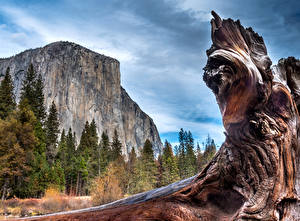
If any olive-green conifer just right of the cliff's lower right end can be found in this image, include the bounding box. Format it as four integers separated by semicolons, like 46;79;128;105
162;140;180;185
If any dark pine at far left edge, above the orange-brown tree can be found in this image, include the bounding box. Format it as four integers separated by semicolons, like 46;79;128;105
0;68;16;119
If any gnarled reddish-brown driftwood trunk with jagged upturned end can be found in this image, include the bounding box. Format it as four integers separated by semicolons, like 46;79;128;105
20;12;300;221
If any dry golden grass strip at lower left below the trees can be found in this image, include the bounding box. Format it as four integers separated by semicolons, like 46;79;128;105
0;188;92;220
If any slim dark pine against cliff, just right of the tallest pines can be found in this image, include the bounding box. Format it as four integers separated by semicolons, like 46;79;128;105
46;101;59;165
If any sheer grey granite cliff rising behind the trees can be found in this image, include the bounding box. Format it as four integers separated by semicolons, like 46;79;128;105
0;42;162;155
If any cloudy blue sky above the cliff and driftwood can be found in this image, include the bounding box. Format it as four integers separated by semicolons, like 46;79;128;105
0;0;300;148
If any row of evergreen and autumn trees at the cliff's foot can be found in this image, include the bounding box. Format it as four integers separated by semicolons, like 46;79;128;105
0;64;216;204
